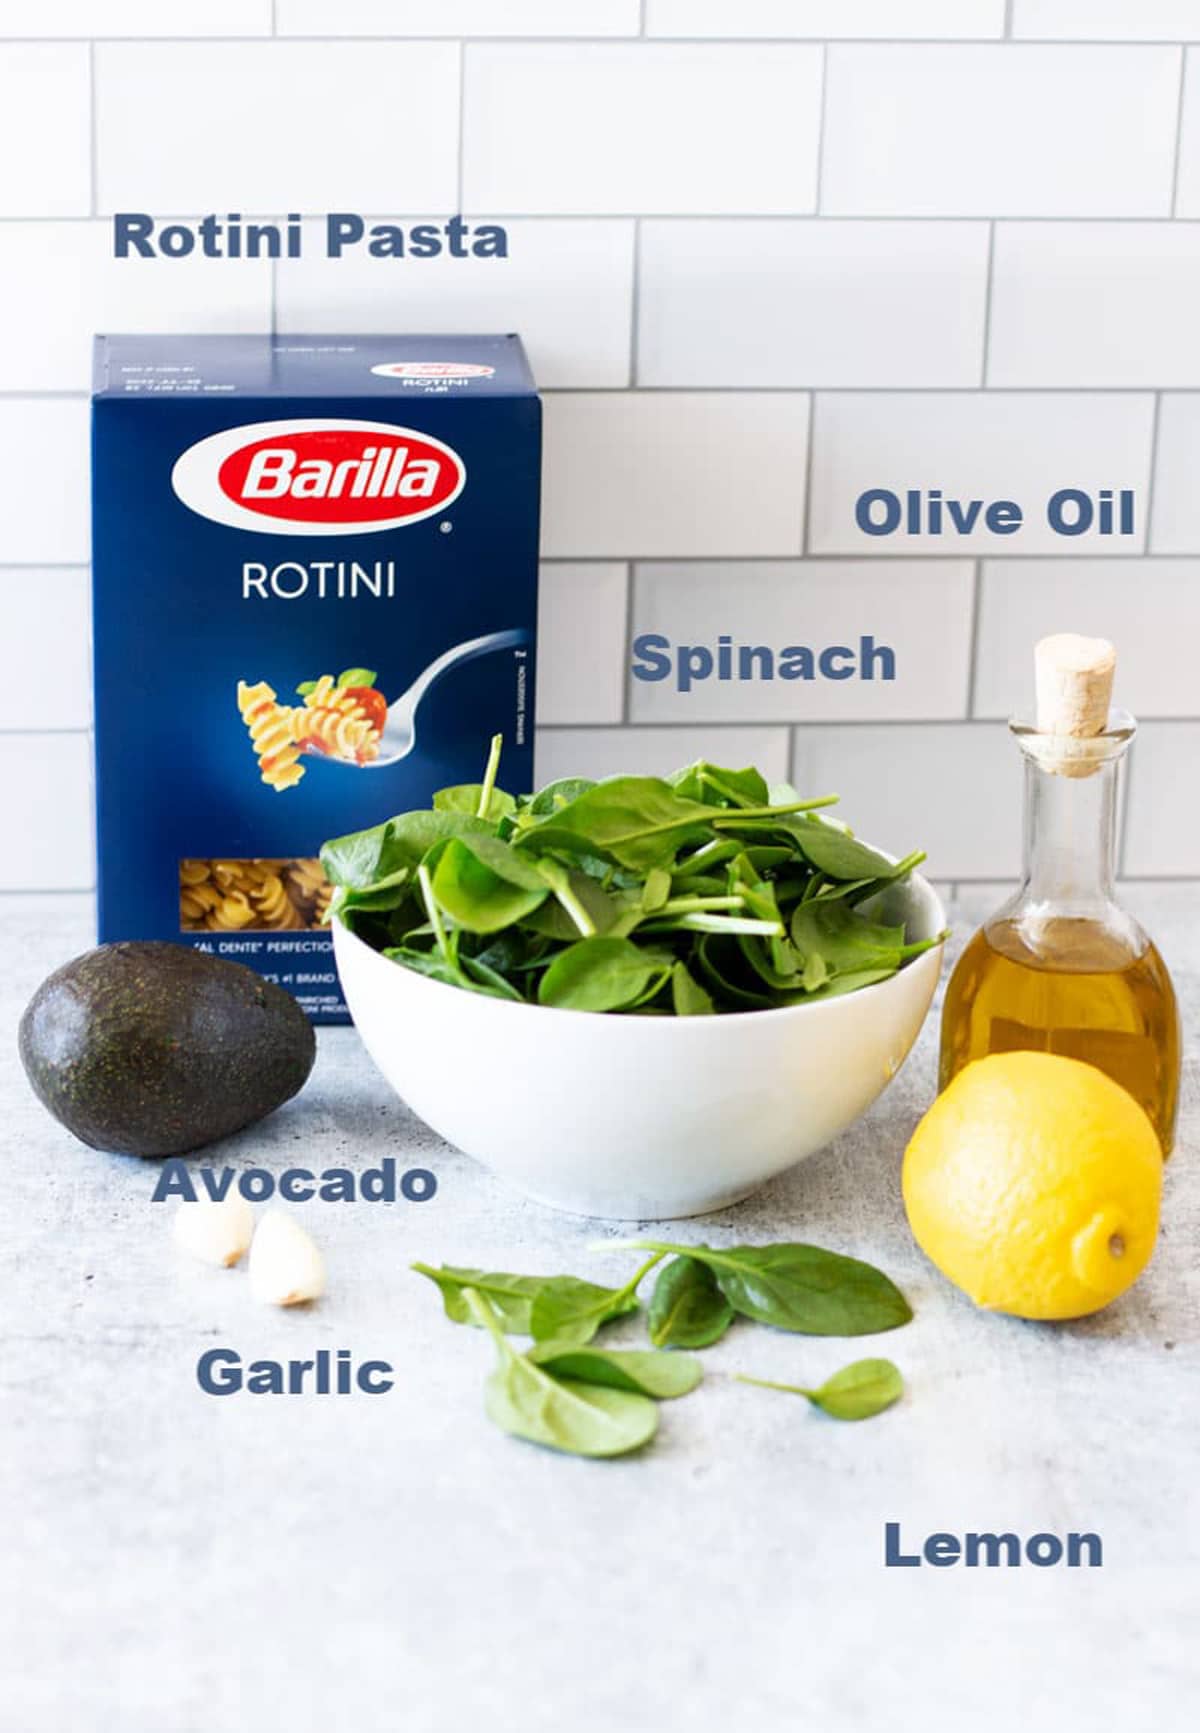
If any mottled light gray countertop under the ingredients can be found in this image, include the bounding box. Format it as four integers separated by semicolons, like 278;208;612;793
0;886;1200;1733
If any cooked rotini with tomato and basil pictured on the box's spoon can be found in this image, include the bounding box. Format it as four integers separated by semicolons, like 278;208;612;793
238;667;387;792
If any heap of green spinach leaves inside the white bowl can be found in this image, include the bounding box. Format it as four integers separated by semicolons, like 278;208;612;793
321;737;943;1017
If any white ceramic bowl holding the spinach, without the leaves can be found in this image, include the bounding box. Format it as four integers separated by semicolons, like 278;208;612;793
333;873;945;1220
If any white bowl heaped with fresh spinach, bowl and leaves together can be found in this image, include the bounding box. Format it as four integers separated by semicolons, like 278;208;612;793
321;740;945;1220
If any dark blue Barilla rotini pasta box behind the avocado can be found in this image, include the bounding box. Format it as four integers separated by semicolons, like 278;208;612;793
92;336;541;1022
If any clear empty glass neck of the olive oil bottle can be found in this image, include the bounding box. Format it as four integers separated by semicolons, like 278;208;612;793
1021;756;1118;918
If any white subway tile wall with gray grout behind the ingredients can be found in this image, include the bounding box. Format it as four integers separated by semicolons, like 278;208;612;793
0;0;1200;891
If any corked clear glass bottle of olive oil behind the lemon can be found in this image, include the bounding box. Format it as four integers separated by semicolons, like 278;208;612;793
940;634;1181;1154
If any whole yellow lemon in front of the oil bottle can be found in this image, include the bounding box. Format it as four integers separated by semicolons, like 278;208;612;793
903;1054;1162;1319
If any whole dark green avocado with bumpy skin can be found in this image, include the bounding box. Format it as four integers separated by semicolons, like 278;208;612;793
19;941;316;1156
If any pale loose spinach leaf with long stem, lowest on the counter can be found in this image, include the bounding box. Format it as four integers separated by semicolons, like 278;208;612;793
463;1288;659;1456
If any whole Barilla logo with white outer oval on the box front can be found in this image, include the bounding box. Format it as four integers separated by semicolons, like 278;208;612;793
172;419;466;535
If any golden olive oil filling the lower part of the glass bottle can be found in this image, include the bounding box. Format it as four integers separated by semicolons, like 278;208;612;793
940;912;1181;1154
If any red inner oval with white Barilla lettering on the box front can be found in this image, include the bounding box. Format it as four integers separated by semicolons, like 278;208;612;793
217;426;465;525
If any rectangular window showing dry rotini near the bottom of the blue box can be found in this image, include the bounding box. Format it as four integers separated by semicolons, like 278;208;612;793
179;860;333;932
